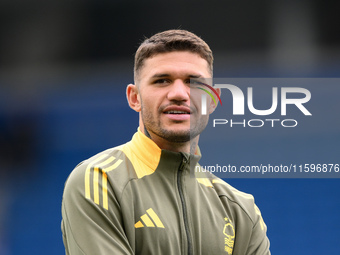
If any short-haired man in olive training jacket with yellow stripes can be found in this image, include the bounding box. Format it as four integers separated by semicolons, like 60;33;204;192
62;30;270;255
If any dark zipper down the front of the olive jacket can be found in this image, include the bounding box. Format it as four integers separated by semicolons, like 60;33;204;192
177;154;193;255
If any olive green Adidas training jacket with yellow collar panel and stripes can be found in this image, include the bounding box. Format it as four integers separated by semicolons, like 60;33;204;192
61;130;270;255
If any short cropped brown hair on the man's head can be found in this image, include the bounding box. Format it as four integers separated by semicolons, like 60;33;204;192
134;29;214;82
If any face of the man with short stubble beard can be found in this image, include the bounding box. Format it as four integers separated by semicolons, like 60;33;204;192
138;52;211;143
